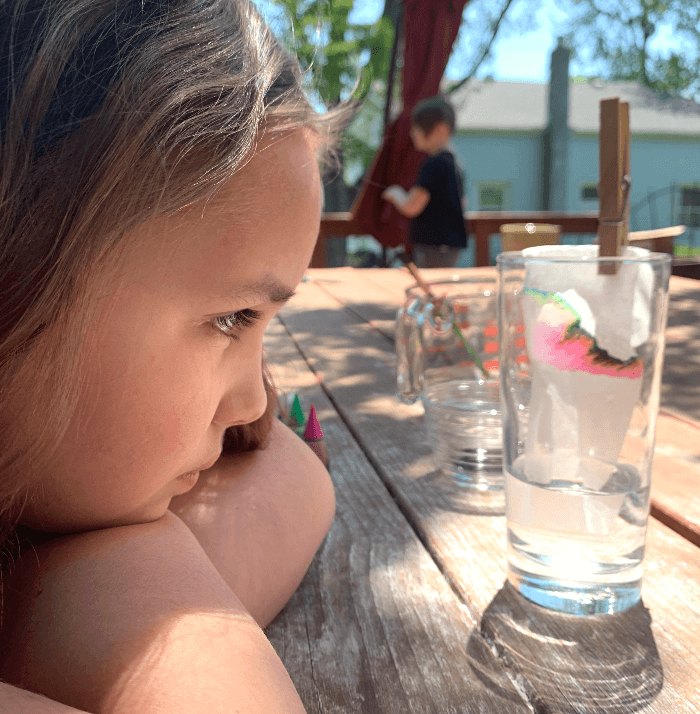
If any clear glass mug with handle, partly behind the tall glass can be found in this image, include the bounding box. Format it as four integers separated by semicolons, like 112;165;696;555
396;274;505;506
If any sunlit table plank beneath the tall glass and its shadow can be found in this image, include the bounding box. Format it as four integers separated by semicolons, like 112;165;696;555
281;275;700;712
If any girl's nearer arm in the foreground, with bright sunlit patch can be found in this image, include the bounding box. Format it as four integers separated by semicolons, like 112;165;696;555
0;512;303;714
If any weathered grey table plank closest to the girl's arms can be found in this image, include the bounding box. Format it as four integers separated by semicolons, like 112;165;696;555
265;323;530;714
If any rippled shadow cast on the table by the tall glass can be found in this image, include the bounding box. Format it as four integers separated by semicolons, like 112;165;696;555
467;582;664;714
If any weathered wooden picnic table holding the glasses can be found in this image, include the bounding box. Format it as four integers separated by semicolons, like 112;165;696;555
266;268;700;714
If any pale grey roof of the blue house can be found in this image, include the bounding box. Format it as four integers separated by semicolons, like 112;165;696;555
450;80;700;136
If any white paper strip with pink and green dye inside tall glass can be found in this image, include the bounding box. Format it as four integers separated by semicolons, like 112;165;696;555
523;246;654;533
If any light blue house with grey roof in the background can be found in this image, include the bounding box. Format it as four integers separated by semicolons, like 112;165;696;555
450;60;700;264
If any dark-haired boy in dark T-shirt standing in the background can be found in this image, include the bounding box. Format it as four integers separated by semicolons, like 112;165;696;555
382;97;467;268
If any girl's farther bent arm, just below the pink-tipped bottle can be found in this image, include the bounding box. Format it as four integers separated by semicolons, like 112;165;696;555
170;420;335;627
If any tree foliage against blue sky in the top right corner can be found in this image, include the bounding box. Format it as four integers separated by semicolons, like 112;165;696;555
560;0;700;102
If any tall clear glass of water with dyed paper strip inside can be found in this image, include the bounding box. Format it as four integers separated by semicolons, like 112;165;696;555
497;246;671;615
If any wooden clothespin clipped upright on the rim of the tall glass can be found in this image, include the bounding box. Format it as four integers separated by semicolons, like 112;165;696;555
598;97;632;275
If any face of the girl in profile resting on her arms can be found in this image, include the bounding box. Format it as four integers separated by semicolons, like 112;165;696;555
21;130;321;531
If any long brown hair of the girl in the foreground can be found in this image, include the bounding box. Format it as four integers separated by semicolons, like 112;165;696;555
0;0;337;541
